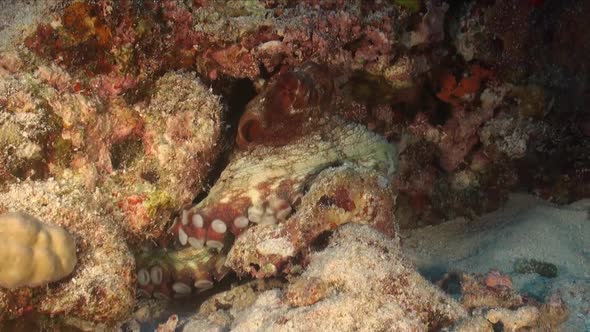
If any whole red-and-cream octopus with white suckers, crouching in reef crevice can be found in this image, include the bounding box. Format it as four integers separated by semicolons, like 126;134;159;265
137;64;397;299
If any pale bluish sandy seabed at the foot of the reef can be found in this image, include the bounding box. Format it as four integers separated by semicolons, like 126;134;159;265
402;194;590;331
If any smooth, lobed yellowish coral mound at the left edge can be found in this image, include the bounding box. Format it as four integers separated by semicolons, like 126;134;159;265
0;213;78;289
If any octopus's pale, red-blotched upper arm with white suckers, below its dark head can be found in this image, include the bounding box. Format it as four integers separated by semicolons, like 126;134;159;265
171;118;396;254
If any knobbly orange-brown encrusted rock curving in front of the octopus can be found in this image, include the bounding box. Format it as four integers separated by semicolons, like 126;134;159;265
226;163;398;278
